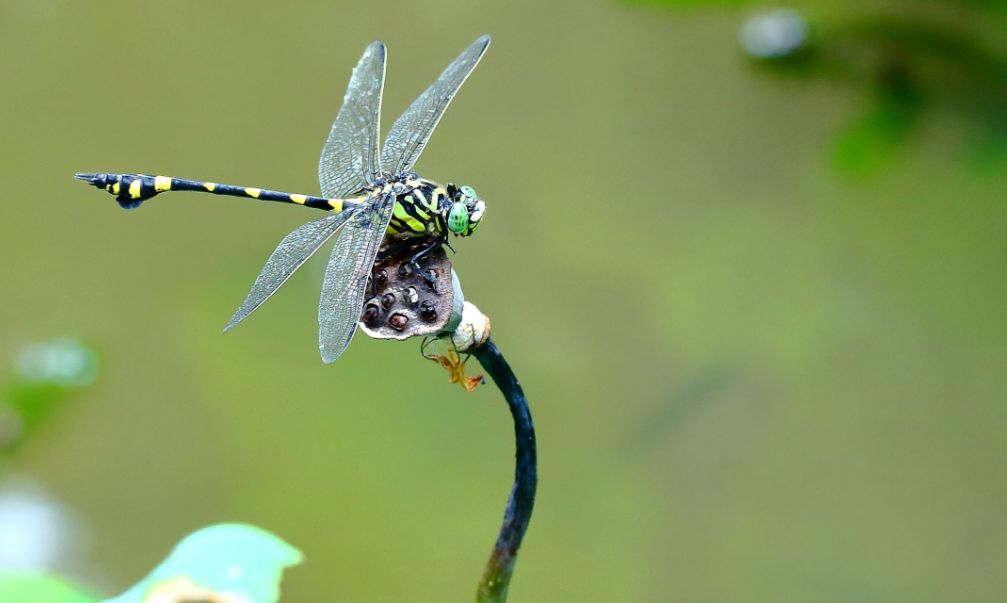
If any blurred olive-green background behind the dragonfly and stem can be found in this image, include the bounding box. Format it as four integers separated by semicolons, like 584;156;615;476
0;0;1007;603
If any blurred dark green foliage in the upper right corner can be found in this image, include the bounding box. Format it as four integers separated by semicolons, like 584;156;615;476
769;9;1007;175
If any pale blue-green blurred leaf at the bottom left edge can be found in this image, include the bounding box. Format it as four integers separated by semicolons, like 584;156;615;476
105;523;302;603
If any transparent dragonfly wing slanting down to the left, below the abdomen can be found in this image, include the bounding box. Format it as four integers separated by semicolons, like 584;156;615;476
224;208;358;332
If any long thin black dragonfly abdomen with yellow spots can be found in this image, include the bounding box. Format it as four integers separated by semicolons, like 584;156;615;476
77;174;359;211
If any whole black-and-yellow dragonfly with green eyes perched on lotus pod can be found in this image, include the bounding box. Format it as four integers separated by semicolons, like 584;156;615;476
76;35;489;363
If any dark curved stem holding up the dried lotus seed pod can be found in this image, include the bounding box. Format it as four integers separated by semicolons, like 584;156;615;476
472;340;538;603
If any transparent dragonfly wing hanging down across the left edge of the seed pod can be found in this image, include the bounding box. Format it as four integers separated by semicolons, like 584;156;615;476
318;194;395;363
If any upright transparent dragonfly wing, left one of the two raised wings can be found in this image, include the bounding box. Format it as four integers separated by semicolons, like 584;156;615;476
318;42;385;198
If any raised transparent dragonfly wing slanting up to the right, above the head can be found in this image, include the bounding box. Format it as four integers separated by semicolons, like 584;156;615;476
381;35;489;175
